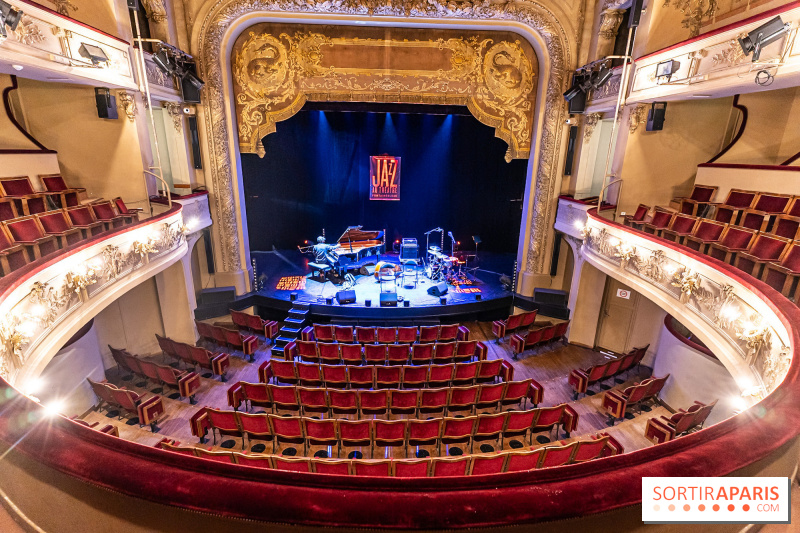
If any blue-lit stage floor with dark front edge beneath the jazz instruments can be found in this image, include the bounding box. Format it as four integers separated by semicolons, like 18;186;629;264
247;250;514;325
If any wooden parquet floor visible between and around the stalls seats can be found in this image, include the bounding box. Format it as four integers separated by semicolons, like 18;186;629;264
81;319;670;458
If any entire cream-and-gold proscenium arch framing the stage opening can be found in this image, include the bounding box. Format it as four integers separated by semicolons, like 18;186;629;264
192;0;574;286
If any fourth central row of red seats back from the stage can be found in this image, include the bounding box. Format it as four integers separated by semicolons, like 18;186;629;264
228;379;544;418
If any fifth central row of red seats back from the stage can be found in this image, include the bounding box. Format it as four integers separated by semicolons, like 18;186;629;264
190;404;578;457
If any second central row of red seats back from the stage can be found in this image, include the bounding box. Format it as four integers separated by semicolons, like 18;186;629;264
283;340;489;365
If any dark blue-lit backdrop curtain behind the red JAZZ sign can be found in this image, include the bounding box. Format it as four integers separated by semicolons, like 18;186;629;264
242;110;528;252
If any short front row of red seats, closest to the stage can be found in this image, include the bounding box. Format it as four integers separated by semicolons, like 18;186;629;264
300;324;469;344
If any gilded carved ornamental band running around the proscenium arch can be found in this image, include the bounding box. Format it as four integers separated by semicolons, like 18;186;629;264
196;0;573;272
